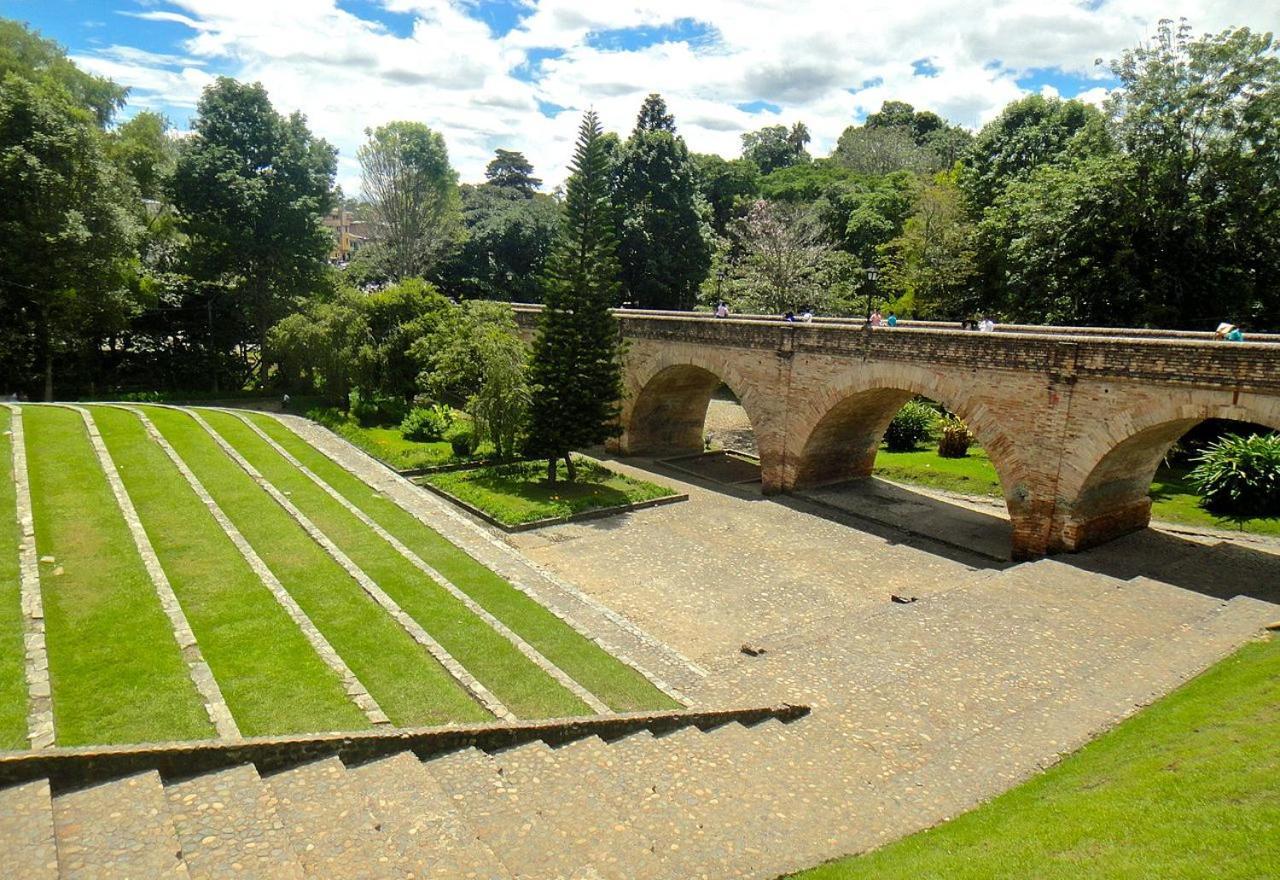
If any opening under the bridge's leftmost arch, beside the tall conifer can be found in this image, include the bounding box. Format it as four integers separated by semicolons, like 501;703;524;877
622;363;756;455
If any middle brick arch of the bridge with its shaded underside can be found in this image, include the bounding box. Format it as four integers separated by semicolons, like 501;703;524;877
787;365;1029;516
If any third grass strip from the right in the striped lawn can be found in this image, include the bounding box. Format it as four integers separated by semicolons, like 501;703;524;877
142;407;492;727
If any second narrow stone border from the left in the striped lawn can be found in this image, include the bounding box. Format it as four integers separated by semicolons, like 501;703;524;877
67;405;241;739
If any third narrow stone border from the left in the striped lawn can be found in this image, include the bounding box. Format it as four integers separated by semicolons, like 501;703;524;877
120;405;392;727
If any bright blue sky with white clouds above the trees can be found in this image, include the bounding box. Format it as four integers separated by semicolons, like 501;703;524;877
0;0;1280;193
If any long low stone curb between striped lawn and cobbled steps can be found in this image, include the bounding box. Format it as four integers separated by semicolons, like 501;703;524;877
0;703;809;789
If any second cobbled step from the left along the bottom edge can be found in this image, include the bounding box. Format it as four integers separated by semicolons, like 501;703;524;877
54;770;189;880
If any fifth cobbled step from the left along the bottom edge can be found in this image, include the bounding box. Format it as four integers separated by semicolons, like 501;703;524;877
348;752;511;880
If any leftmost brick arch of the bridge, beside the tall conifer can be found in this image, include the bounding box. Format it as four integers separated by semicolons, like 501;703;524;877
618;347;768;460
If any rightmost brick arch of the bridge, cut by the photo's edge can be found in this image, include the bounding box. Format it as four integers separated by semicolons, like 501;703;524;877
1051;391;1280;550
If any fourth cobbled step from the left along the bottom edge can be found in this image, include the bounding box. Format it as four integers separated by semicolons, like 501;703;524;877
264;757;408;880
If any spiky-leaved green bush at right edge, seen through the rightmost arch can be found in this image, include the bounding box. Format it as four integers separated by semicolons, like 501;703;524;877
1188;434;1280;519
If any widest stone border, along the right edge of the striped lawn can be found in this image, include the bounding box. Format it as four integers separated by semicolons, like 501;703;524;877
268;413;709;706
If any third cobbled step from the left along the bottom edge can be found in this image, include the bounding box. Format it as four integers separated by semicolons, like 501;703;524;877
165;764;303;880
